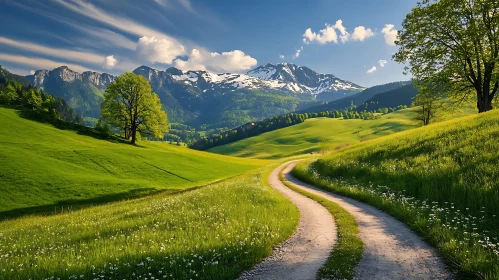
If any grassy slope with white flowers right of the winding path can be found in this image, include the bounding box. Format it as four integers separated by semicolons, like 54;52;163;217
293;111;499;279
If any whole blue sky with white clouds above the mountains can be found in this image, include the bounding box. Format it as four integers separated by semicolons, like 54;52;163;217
0;0;417;87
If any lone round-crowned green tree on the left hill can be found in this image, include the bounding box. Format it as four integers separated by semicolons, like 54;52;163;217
101;73;169;144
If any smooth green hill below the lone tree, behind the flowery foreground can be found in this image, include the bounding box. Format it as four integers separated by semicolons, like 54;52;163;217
0;107;269;219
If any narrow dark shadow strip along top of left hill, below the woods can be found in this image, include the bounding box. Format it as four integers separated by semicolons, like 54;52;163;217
10;106;131;147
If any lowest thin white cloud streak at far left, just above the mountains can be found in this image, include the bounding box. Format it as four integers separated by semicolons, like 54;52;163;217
0;53;96;72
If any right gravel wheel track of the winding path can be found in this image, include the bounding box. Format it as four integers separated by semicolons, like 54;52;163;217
283;162;453;279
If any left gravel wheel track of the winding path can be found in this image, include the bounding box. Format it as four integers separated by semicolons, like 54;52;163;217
239;163;337;280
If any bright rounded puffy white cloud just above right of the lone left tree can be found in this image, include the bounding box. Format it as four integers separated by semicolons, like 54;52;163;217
137;36;185;64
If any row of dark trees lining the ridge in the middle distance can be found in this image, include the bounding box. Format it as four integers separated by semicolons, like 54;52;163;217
189;106;407;150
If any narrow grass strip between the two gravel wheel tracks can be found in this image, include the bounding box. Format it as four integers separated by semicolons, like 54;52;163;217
279;168;364;279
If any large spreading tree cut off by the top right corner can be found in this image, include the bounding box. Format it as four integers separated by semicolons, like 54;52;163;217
394;0;499;112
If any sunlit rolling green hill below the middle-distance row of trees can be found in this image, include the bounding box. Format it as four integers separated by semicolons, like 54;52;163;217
209;109;419;159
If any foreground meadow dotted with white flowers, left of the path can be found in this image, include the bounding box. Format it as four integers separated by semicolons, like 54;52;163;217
0;167;299;280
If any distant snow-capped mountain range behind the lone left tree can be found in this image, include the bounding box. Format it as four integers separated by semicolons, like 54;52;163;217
26;63;364;127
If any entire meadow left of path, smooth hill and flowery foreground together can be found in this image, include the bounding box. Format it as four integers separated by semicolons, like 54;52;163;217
0;108;299;280
